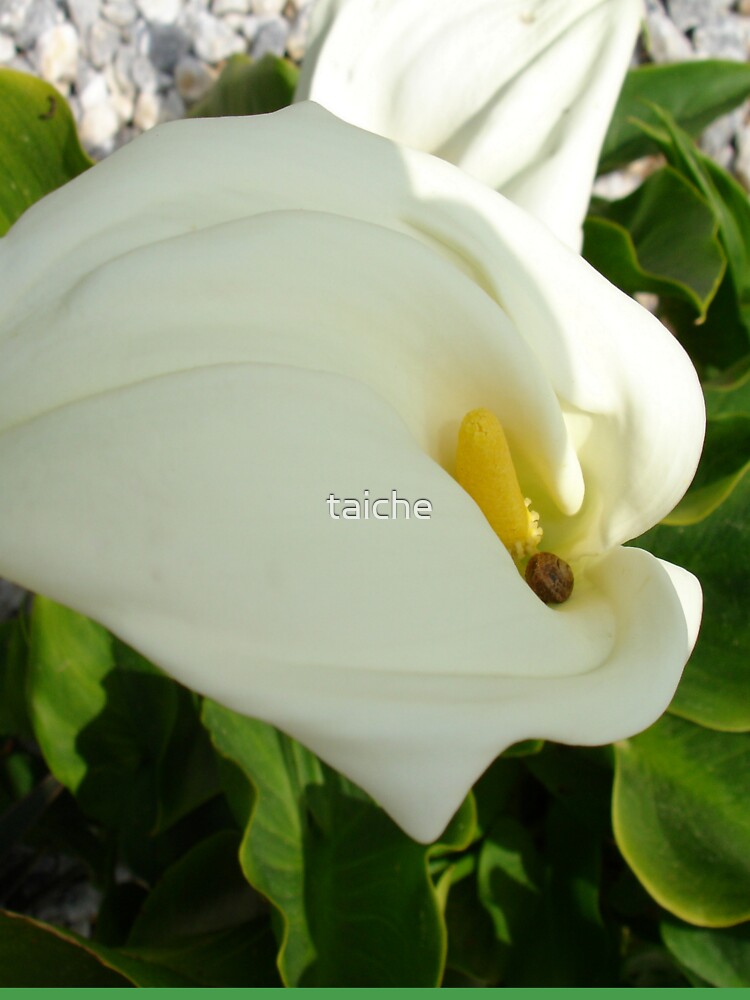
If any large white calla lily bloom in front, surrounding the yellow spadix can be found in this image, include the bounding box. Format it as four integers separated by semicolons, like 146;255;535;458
0;104;704;841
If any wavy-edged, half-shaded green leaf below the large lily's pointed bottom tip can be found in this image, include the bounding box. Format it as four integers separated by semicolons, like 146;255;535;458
204;702;474;987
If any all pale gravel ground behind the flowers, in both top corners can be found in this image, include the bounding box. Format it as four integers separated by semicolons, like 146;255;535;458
0;0;750;176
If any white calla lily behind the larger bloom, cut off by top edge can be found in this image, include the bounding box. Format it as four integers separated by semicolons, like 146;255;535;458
297;0;643;249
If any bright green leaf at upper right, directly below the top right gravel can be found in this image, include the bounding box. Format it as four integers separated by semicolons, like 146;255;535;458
599;59;750;173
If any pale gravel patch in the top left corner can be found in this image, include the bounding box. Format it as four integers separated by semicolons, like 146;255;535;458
0;0;310;158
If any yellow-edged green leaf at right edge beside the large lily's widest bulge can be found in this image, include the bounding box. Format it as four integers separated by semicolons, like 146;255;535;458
664;413;750;525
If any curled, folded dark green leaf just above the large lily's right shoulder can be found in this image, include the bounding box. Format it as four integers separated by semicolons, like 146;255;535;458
583;167;726;318
